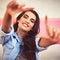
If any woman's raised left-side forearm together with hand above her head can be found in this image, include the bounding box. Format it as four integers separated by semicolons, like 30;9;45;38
2;0;33;33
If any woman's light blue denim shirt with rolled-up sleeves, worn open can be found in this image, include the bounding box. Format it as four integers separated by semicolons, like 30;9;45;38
0;27;46;60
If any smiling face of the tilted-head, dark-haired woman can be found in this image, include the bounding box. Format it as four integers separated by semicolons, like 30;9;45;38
18;11;36;32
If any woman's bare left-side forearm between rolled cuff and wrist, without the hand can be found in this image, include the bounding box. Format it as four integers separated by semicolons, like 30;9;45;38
2;12;11;33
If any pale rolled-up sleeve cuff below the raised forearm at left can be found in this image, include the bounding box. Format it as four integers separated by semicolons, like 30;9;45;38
0;26;14;43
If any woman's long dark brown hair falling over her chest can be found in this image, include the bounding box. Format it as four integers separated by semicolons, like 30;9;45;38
14;10;40;60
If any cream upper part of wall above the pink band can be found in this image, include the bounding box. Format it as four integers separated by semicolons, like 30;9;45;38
0;0;60;18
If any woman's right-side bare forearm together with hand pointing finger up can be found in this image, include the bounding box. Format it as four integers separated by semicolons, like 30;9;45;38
37;16;60;47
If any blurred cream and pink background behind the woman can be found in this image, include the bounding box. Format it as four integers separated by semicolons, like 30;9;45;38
0;0;60;60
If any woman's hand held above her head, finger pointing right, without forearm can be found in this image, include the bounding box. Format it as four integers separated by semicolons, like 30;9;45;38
7;0;33;16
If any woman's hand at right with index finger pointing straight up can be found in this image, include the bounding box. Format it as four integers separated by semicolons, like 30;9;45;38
45;16;60;43
